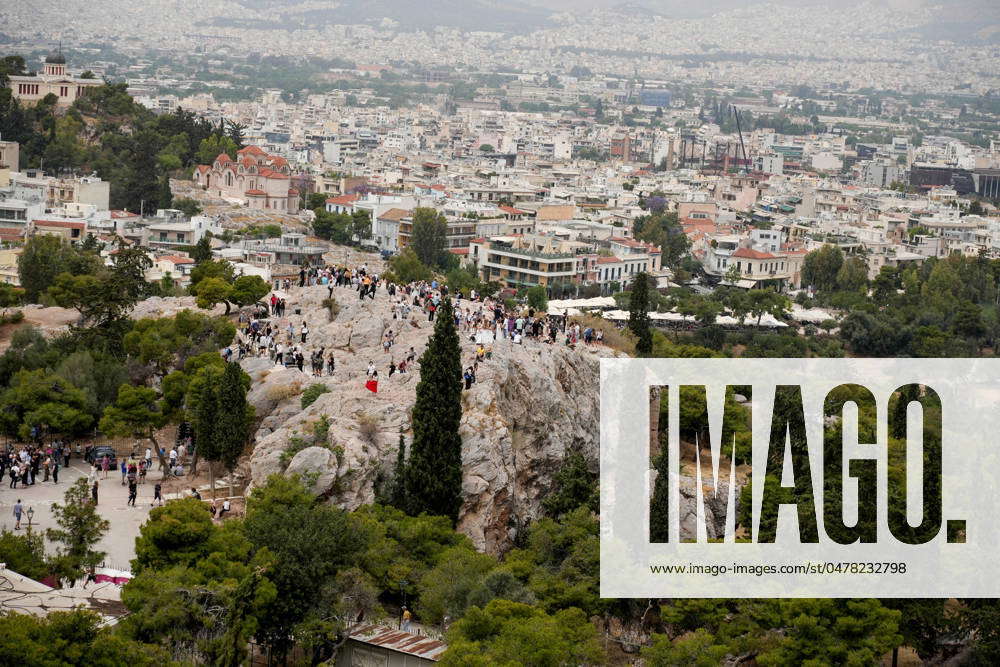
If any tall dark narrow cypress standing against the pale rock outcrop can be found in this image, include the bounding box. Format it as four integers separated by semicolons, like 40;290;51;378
404;299;462;523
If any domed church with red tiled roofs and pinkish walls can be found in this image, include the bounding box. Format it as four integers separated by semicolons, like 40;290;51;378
194;146;299;213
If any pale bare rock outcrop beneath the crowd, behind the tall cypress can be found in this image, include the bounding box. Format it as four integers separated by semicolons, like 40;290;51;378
243;286;614;552
